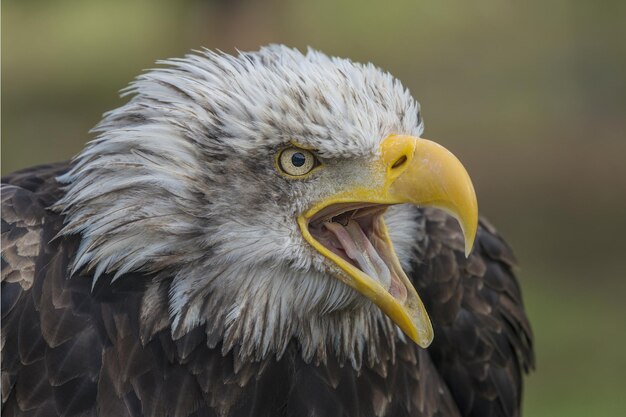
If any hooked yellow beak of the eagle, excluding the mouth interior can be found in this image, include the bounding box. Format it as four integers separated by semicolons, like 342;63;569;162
298;135;478;347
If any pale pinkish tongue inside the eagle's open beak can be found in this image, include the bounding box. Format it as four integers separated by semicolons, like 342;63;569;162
325;220;391;289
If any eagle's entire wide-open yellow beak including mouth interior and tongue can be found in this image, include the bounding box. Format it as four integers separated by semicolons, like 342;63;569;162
296;135;478;348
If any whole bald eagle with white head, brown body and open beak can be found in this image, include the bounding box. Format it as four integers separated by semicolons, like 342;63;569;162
2;45;533;417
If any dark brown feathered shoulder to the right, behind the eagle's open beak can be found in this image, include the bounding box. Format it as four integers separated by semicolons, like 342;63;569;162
412;209;534;417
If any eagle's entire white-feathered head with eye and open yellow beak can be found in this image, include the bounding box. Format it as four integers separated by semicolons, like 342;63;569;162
57;46;477;366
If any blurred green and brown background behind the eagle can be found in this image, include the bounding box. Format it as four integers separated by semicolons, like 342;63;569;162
2;0;626;417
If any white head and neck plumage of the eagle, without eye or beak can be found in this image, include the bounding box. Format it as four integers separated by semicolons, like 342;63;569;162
57;46;423;367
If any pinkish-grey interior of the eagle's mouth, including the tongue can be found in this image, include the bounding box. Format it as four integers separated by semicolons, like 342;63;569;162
308;203;407;304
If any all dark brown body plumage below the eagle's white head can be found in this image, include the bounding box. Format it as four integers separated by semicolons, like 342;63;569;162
2;165;533;417
